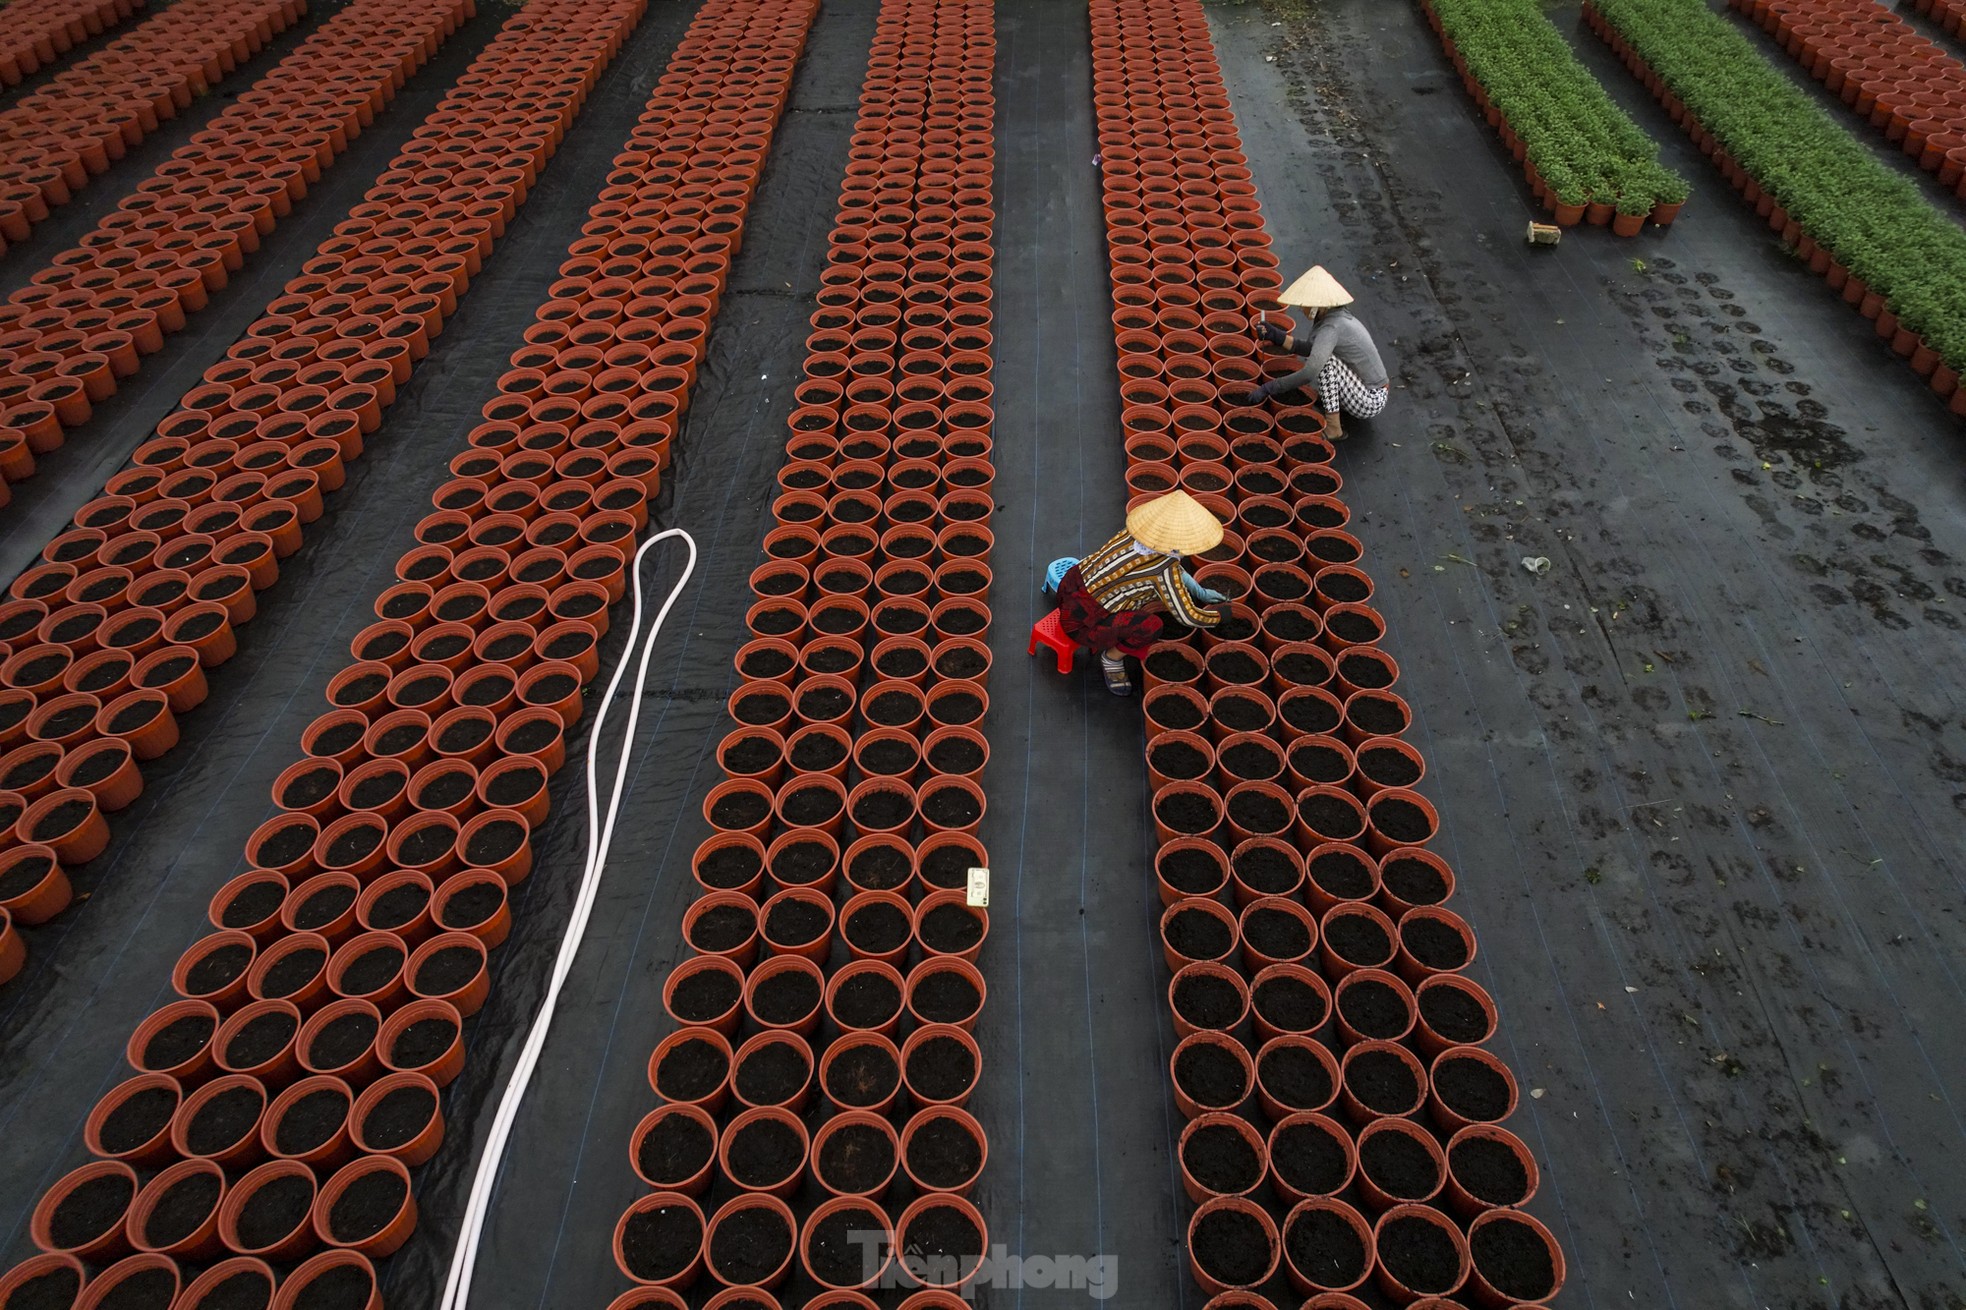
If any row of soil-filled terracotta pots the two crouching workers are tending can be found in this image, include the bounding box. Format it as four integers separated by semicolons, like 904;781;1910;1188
1093;0;1561;1304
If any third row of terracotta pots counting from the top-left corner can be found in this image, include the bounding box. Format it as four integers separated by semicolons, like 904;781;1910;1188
0;0;466;476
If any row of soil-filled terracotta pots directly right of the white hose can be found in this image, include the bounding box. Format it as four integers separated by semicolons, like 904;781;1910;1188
615;2;993;1310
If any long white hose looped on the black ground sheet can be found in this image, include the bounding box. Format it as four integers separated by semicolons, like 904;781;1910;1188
442;527;696;1310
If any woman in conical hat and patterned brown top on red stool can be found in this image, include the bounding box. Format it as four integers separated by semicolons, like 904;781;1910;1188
1046;492;1229;696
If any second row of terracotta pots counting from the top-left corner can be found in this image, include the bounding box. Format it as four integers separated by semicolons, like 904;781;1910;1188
0;0;307;247
